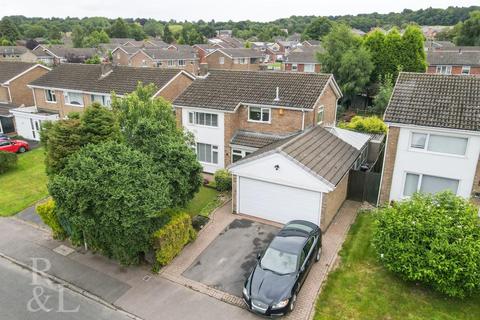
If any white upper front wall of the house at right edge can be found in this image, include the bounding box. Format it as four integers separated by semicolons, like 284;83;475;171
390;127;480;200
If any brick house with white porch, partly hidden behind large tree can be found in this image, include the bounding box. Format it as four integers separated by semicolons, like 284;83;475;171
10;64;195;140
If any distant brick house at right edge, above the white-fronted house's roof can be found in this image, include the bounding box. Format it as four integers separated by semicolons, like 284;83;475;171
427;47;480;76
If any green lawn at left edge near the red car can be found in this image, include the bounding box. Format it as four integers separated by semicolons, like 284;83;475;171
0;148;48;217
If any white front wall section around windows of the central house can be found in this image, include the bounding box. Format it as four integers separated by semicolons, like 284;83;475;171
182;108;225;173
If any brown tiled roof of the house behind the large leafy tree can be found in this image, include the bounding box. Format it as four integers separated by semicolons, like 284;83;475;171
30;63;186;95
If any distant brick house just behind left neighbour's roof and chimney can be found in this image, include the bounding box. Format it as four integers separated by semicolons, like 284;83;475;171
129;47;200;75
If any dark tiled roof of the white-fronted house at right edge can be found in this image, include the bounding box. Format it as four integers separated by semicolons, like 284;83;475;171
384;72;480;131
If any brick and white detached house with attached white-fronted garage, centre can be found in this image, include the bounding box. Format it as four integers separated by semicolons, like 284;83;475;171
173;70;369;229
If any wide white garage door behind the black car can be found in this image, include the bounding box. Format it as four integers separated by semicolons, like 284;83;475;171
237;177;321;225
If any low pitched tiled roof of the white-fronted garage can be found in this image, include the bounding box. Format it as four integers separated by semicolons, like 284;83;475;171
231;126;360;186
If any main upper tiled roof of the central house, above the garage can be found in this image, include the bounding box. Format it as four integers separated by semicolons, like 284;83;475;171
174;70;333;111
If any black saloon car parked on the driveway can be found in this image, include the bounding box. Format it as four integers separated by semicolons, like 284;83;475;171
243;220;322;316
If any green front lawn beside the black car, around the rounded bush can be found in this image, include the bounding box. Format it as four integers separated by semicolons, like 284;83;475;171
315;214;480;320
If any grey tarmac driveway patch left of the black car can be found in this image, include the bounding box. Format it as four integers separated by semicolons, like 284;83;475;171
182;219;279;297
